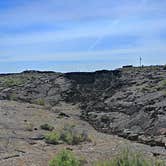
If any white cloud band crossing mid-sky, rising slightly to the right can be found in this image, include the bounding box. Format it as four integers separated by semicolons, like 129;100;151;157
0;19;166;46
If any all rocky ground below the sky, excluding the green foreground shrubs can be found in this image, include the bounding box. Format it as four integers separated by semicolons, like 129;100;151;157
0;66;166;166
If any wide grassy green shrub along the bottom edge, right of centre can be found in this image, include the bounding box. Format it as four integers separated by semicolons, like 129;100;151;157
94;150;165;166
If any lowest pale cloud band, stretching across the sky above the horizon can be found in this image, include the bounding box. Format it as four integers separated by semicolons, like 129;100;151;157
0;43;166;62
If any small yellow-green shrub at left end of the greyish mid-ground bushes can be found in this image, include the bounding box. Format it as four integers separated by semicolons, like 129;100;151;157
45;132;60;145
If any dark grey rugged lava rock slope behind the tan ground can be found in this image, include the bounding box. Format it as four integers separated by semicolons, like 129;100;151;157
0;66;166;146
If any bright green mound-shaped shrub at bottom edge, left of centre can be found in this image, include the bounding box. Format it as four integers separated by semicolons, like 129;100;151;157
49;150;81;166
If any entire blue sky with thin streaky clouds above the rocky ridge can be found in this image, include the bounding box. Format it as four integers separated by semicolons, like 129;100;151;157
0;0;166;73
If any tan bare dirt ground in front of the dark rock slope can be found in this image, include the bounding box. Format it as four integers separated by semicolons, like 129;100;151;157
0;101;166;166
